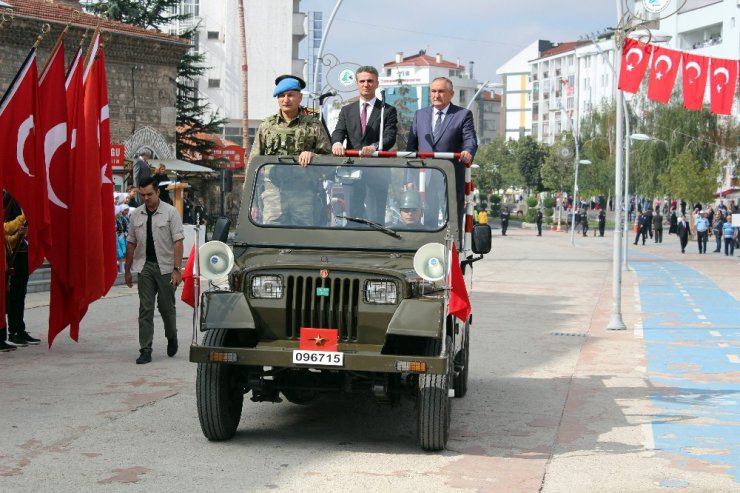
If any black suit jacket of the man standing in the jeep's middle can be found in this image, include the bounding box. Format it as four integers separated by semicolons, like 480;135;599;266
331;99;398;151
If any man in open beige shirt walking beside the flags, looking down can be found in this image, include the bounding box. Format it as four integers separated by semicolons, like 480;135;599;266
125;176;185;365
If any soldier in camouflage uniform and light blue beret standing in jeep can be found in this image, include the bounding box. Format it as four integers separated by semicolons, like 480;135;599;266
250;75;331;226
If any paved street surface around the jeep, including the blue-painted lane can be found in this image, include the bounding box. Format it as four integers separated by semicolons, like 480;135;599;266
0;228;740;492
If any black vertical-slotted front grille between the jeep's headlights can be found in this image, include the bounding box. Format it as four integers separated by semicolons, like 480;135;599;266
285;276;362;341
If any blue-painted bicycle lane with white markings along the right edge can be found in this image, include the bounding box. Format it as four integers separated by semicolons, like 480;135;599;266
630;253;740;483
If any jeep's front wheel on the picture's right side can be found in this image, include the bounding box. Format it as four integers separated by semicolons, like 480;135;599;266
417;375;450;450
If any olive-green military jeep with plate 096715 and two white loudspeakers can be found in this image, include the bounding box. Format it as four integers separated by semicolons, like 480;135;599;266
190;156;491;450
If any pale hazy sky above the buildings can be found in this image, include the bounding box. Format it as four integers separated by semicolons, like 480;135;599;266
300;0;617;81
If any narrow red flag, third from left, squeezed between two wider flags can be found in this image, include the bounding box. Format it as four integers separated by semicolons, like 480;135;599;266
49;48;84;348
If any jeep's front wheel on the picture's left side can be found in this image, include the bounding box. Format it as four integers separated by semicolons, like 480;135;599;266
195;329;244;441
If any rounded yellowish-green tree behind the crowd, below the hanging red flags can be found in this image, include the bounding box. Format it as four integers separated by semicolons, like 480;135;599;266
659;148;718;203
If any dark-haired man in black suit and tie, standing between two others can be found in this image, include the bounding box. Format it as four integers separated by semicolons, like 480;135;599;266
331;66;398;223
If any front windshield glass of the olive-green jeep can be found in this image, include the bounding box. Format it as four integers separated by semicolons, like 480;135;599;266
248;160;449;232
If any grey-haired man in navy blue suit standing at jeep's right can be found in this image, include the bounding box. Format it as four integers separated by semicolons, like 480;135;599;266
406;77;478;231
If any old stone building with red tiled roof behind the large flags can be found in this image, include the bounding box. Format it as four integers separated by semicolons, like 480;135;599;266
0;0;189;160
